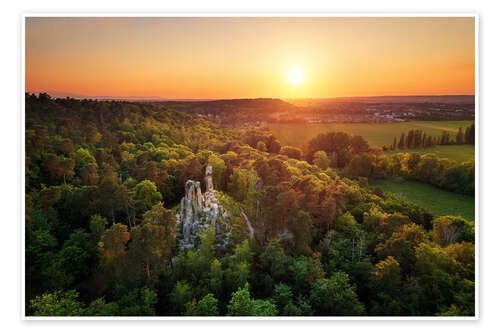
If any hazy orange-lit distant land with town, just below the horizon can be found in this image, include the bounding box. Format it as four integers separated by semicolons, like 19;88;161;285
148;95;475;125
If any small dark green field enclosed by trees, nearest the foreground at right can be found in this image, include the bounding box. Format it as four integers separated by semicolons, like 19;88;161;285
372;180;474;221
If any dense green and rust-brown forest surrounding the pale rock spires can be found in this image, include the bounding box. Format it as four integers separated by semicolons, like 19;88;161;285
25;93;475;316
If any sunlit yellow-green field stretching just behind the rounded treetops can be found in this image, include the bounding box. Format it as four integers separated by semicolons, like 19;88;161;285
268;120;474;147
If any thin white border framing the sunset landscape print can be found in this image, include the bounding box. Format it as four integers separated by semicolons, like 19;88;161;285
19;11;480;321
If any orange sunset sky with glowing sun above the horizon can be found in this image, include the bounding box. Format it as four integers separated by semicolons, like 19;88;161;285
25;17;475;99
